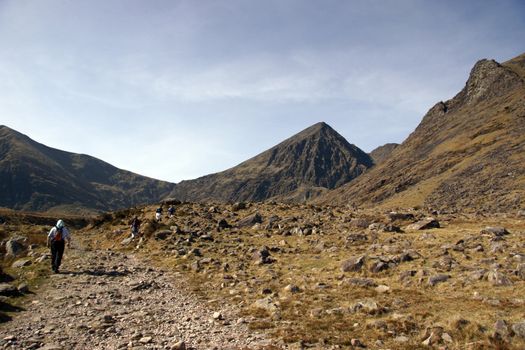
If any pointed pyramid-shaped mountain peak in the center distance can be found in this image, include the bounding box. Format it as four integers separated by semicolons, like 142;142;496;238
172;123;373;202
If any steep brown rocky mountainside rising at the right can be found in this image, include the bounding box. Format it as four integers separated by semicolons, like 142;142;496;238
319;55;525;211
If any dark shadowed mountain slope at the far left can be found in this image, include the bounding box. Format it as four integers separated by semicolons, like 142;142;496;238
0;126;175;211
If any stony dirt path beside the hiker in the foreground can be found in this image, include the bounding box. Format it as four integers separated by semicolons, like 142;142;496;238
0;241;264;350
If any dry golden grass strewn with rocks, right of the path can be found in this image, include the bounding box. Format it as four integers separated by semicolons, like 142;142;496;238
81;204;525;349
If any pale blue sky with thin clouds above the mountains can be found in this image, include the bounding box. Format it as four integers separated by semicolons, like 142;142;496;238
0;0;525;182
